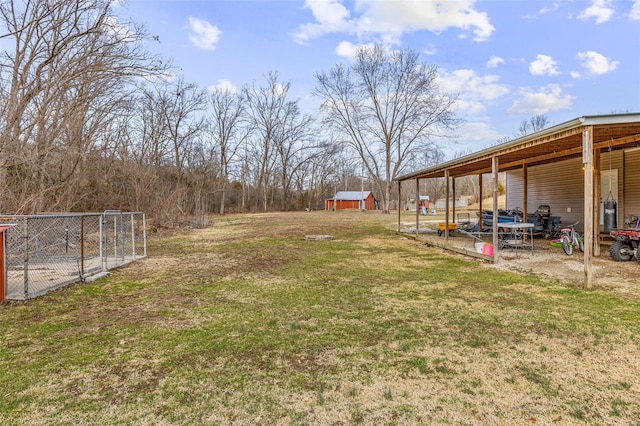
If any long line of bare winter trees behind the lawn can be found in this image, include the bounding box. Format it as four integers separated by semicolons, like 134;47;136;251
0;0;455;226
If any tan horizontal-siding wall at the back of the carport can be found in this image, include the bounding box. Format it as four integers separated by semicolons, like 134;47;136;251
506;151;640;230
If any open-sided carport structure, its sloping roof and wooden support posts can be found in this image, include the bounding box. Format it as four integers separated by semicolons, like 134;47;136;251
397;113;640;289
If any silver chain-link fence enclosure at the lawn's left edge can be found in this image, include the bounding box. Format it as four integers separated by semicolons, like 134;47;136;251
0;210;147;300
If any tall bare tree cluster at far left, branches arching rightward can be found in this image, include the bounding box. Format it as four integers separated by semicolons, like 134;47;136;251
0;0;166;211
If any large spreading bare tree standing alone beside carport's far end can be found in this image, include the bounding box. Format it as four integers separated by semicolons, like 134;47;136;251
315;46;458;213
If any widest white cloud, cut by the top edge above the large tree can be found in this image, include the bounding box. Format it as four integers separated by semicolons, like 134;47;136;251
294;0;494;44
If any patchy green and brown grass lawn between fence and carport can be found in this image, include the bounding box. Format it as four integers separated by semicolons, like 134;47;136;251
0;212;640;425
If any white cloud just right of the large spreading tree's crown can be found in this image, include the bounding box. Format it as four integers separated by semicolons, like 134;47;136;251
437;69;509;114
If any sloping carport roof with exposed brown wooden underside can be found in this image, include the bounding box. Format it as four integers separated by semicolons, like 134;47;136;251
396;113;640;182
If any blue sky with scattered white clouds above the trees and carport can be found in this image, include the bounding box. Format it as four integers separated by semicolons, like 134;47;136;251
117;0;640;154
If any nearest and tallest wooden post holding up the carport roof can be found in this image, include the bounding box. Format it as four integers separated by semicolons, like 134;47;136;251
582;126;594;290
